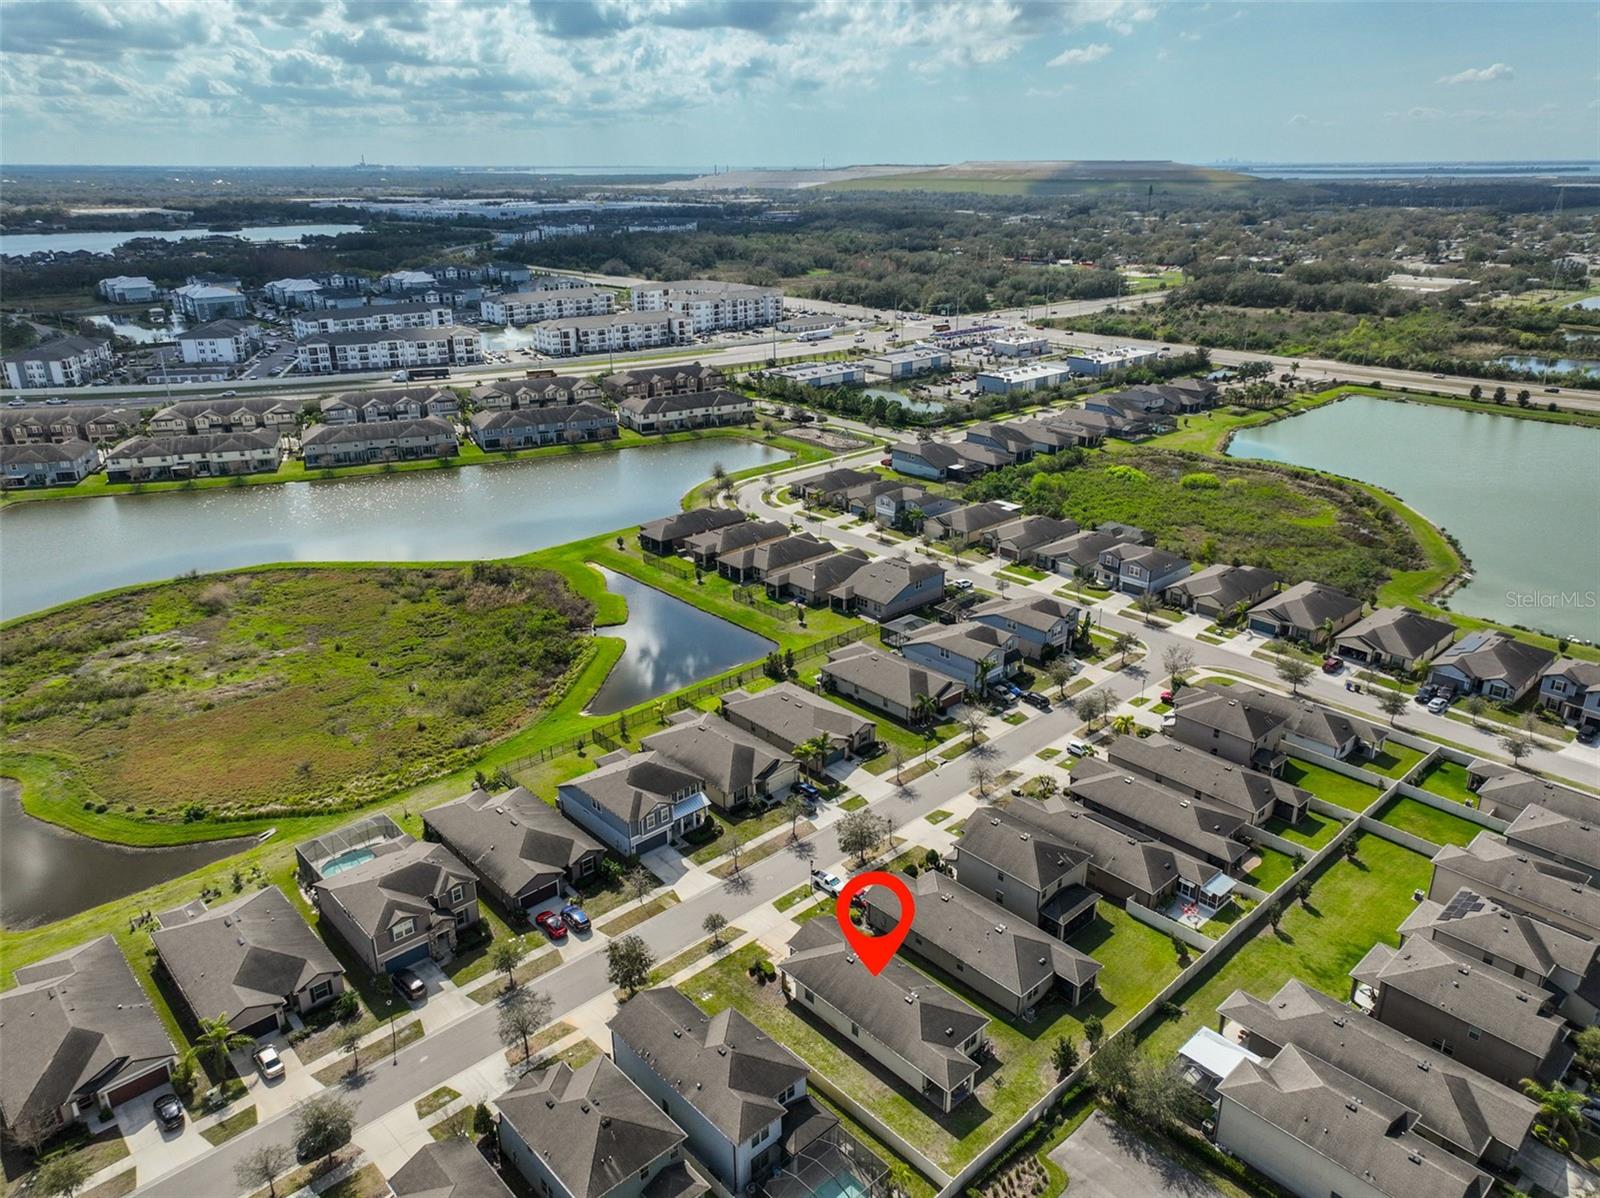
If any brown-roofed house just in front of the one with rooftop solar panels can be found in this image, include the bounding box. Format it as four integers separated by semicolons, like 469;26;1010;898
1350;937;1573;1086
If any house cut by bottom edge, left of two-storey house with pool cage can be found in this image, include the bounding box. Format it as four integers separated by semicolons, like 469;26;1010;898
494;1056;706;1198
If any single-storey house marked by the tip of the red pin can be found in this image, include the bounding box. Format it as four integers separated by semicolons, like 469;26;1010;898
778;920;989;1113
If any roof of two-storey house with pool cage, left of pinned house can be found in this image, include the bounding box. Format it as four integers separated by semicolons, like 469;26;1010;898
611;987;810;1144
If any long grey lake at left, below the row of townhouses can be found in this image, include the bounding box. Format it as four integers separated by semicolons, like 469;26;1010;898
0;438;786;619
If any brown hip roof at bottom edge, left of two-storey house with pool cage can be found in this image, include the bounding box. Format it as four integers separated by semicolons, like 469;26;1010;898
494;1056;683;1198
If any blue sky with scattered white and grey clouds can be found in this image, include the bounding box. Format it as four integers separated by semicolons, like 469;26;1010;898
0;0;1600;170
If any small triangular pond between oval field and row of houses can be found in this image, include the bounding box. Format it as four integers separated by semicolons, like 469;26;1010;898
587;568;778;715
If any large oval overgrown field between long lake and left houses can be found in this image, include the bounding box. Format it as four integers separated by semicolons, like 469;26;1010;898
0;565;594;838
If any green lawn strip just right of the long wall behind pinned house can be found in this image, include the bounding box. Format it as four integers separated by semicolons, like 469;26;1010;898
1141;833;1432;1060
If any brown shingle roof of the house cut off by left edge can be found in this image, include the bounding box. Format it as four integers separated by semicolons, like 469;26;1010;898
0;936;174;1128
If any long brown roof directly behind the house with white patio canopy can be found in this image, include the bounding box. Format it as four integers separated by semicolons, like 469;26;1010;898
1216;977;1539;1158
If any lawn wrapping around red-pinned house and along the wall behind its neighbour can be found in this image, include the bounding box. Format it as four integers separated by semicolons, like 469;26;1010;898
678;904;1178;1171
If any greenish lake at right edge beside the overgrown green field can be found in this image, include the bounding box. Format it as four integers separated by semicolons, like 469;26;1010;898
1227;395;1600;641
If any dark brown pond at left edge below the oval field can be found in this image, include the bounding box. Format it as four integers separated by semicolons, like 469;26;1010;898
0;777;254;931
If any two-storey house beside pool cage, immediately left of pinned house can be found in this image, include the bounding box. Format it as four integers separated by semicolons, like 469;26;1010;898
610;987;816;1195
